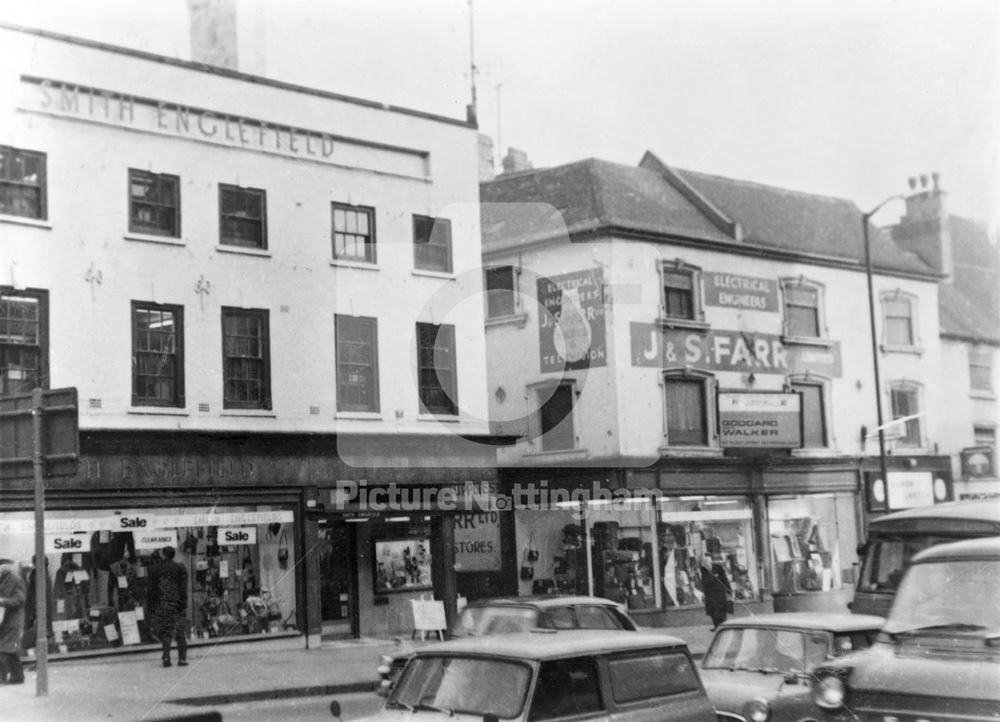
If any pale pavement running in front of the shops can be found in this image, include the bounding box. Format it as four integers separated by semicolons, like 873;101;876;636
0;624;712;722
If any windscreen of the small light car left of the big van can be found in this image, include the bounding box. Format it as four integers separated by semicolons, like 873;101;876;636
702;627;832;672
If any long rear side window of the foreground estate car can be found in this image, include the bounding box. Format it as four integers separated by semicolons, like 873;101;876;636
608;651;699;702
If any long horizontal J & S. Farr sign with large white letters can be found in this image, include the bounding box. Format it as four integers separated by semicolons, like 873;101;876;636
631;322;841;378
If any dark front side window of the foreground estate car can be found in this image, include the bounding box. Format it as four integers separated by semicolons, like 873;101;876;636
529;657;604;722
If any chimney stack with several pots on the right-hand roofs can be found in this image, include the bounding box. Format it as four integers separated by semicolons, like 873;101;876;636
892;173;954;278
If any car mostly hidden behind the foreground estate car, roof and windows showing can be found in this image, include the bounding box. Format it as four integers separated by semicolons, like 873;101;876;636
377;594;637;694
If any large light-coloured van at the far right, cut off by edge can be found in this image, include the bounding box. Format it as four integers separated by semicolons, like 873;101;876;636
813;537;1000;722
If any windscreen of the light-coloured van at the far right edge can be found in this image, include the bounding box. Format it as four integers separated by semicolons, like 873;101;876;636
883;560;1000;634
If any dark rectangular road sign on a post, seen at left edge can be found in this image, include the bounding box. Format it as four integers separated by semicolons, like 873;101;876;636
0;388;80;697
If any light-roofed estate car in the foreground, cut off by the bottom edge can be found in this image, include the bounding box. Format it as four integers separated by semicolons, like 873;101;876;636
346;629;716;722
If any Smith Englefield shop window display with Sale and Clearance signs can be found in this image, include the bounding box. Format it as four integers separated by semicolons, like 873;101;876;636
0;505;297;652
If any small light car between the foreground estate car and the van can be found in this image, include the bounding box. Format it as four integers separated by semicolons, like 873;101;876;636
701;612;885;722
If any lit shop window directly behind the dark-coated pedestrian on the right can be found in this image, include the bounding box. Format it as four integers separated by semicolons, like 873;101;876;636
657;496;760;608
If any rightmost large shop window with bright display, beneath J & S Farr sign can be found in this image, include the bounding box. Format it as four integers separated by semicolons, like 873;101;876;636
768;494;858;594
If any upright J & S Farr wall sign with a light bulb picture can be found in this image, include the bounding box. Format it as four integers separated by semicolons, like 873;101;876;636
538;268;608;373
